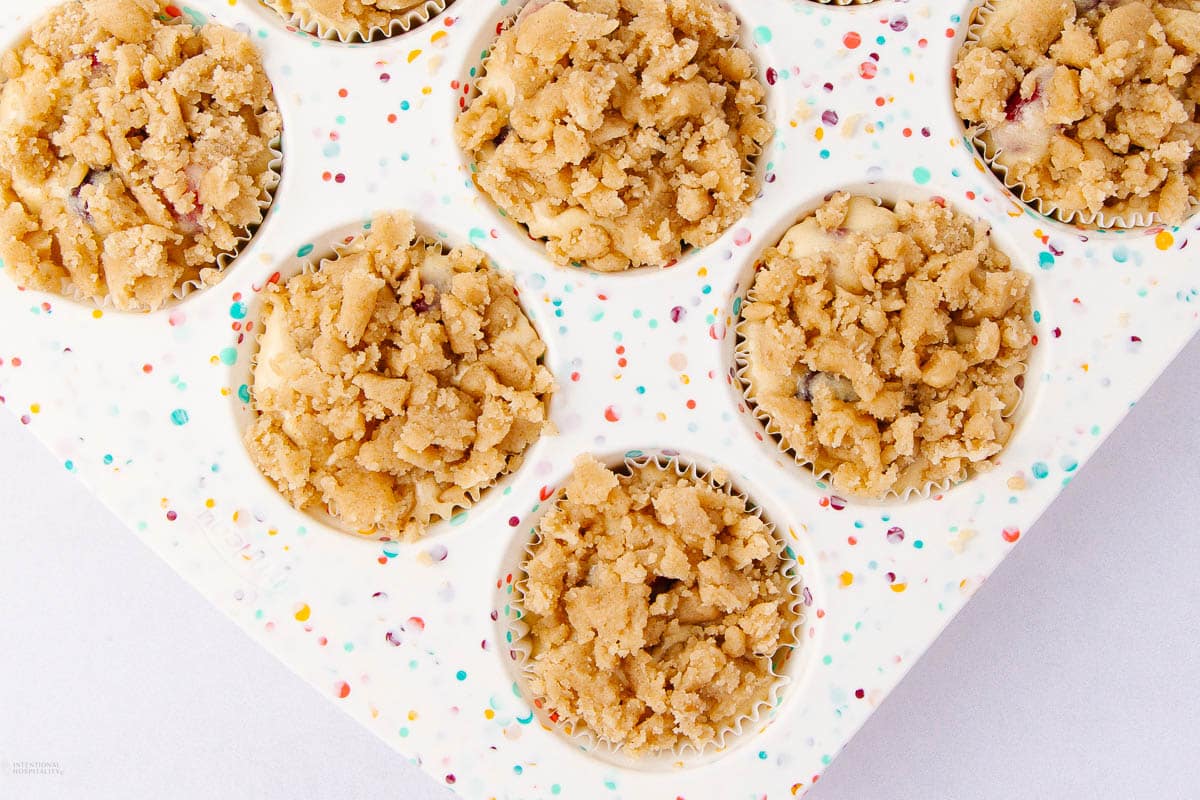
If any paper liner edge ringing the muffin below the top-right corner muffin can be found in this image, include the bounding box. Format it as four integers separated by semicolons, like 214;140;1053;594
731;185;1037;504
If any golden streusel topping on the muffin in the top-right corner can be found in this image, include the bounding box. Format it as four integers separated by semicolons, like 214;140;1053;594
954;0;1200;224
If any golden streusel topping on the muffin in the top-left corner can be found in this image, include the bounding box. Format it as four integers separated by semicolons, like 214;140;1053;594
0;0;280;311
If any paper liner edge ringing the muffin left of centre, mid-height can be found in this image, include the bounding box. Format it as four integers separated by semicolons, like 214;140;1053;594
237;218;551;542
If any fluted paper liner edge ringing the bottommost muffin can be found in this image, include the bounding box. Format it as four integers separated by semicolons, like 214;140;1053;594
498;450;805;770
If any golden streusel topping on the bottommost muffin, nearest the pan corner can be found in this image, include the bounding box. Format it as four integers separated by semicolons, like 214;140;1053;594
520;456;796;756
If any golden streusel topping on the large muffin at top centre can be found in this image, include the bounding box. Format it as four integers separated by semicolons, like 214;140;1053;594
455;0;772;272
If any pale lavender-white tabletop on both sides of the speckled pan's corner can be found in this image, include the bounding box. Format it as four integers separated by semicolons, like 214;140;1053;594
0;341;1200;800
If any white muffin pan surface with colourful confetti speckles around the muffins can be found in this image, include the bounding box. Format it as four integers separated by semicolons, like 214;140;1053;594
0;0;1200;800
